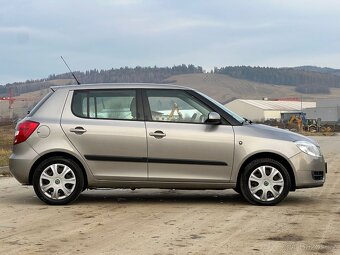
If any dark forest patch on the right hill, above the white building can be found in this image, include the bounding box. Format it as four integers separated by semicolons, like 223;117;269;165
214;66;340;93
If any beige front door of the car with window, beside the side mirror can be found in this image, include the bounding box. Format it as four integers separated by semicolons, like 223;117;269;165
144;89;234;182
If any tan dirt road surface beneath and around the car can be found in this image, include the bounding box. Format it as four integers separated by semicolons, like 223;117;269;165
0;136;340;255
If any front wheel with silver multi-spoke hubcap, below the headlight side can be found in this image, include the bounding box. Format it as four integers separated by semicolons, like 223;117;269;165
240;158;291;205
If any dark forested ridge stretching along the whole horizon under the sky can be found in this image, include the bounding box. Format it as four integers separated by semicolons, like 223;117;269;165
0;64;340;96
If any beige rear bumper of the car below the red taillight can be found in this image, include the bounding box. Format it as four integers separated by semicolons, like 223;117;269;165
9;142;38;184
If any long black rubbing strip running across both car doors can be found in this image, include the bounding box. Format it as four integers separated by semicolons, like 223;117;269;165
85;155;228;166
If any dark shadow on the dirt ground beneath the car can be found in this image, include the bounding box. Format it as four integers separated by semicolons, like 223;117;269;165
0;187;322;207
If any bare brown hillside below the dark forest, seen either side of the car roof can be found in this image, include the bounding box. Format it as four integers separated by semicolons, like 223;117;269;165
0;73;340;119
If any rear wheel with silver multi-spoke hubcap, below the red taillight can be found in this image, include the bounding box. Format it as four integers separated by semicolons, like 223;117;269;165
33;156;84;205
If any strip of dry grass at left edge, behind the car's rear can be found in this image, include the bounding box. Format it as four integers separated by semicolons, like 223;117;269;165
0;126;14;166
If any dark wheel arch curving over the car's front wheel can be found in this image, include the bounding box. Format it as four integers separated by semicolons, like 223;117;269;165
236;152;296;191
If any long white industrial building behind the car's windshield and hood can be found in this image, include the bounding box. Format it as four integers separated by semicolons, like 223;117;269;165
225;99;316;121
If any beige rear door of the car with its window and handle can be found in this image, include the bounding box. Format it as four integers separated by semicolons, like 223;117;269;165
61;89;147;180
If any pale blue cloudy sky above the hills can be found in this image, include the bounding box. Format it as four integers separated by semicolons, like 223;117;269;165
0;0;340;84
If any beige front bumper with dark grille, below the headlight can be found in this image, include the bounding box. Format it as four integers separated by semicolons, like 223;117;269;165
290;152;327;189
